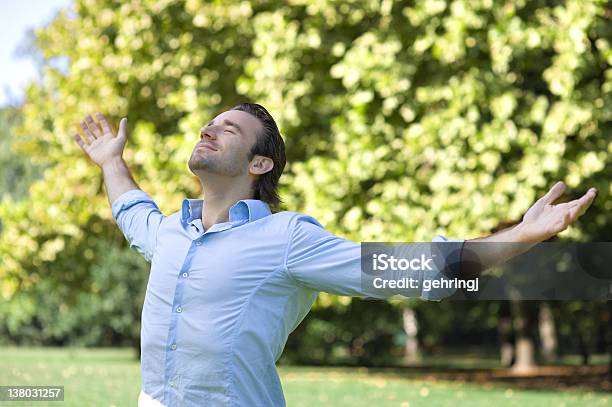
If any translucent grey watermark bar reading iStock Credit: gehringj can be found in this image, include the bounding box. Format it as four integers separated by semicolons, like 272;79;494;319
361;241;612;300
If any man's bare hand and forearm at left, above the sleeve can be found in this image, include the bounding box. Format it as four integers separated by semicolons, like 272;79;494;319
74;113;138;205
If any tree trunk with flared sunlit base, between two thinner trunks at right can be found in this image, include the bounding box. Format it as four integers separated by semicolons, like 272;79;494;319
512;301;536;373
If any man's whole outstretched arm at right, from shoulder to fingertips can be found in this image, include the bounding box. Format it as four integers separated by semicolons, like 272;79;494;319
285;183;596;299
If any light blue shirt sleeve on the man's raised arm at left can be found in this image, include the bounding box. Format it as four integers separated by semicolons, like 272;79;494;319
112;189;164;262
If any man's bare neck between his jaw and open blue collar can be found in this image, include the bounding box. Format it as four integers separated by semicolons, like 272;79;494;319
202;180;253;230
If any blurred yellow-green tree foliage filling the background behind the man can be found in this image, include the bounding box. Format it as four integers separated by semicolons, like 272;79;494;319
0;0;612;366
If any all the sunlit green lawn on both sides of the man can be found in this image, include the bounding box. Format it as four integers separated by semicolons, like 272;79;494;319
0;348;612;407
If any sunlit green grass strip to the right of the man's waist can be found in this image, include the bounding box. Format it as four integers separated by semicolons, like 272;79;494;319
281;367;612;407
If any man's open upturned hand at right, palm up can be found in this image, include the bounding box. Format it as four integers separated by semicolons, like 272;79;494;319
519;181;597;243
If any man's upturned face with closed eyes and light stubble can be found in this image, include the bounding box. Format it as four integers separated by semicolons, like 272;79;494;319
189;110;262;177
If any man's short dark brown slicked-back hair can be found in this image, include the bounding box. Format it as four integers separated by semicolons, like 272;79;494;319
231;103;287;207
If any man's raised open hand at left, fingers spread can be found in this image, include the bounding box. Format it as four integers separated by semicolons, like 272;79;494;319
74;113;127;167
